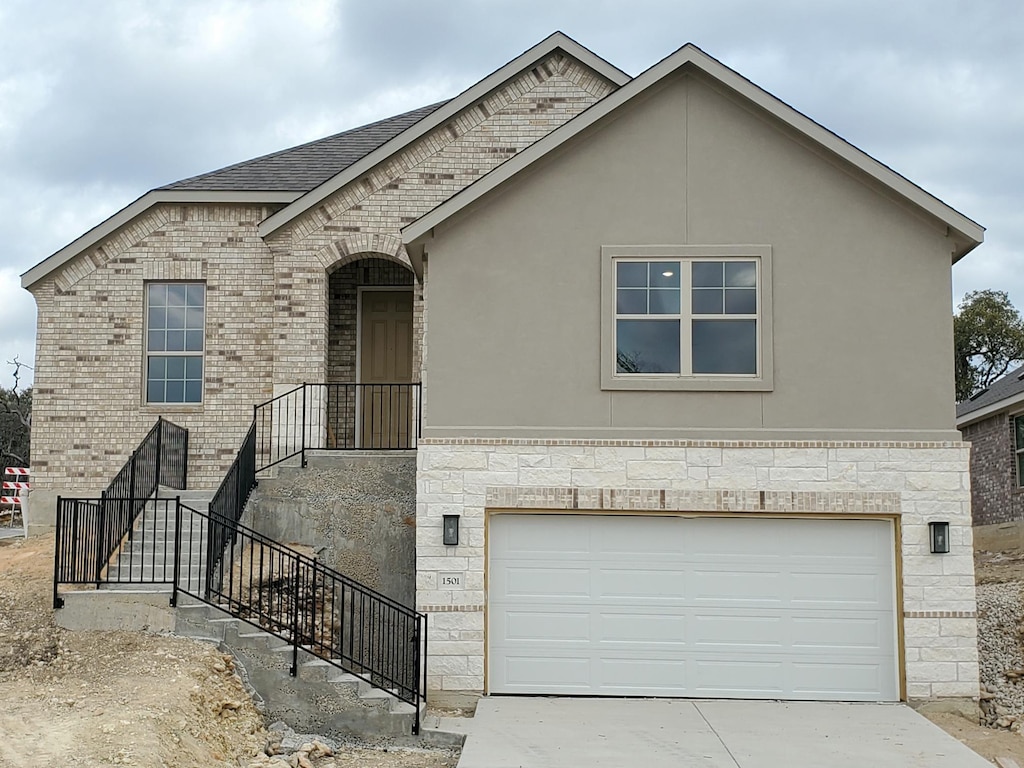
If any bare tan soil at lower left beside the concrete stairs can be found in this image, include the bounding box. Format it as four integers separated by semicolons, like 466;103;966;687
0;535;458;768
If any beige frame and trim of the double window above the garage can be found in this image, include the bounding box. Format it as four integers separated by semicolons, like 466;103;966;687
601;245;773;391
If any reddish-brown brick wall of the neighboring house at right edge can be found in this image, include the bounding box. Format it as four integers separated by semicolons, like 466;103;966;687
961;414;1024;525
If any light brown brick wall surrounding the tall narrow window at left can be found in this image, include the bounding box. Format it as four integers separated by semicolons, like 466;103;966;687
32;205;273;494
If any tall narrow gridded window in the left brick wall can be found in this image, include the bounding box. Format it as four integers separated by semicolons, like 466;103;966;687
145;283;206;403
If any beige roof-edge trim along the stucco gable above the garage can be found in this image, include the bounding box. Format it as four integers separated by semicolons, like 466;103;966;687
401;43;985;271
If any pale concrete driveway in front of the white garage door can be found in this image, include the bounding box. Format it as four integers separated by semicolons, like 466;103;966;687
459;697;991;768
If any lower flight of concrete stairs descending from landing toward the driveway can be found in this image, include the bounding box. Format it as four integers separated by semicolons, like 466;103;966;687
174;601;426;738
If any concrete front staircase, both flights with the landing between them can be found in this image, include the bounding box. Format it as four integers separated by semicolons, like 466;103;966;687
56;489;423;744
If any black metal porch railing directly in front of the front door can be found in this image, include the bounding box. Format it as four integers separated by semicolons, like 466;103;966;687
253;383;421;472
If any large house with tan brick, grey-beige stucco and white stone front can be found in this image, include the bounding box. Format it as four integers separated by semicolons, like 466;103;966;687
24;34;983;700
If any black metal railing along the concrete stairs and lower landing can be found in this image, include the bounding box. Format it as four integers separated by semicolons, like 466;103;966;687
53;409;427;733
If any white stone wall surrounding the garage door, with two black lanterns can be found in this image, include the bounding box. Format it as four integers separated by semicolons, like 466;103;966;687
417;438;978;699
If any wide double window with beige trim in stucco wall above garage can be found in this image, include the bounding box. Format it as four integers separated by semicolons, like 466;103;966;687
601;246;772;391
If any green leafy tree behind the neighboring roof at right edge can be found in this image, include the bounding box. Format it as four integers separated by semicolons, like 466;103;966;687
953;290;1024;402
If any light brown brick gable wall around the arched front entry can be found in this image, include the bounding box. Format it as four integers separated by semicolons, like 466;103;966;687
269;54;613;384
